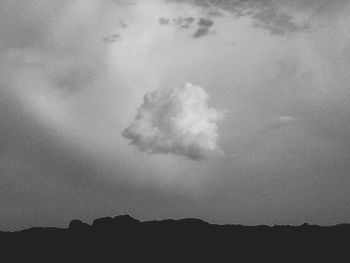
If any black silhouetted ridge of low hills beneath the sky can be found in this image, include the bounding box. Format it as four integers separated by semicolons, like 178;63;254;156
0;215;350;262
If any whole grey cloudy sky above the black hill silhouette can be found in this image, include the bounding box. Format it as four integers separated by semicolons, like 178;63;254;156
0;0;350;230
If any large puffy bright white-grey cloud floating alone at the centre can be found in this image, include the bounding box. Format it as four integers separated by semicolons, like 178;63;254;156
123;83;223;160
